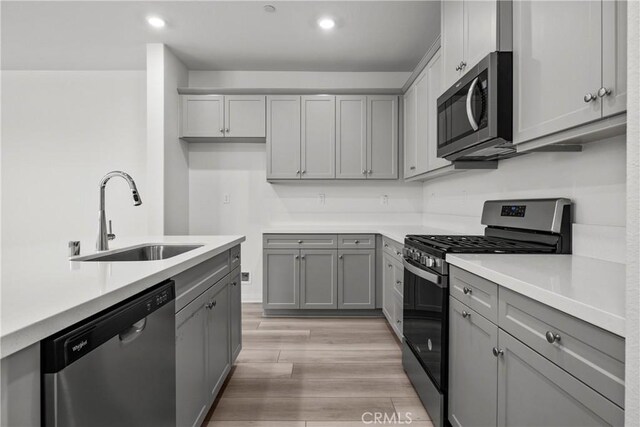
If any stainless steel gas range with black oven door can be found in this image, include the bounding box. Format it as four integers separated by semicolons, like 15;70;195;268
402;199;572;427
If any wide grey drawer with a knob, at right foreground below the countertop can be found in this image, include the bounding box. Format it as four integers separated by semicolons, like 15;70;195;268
499;289;624;407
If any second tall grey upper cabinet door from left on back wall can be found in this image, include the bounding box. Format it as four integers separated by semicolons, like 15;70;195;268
301;95;336;179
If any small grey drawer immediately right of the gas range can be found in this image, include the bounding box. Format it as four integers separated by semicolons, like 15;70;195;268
449;266;498;323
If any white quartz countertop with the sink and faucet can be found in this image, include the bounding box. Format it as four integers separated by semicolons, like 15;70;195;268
0;236;245;357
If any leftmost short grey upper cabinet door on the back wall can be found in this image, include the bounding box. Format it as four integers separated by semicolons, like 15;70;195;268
180;95;224;138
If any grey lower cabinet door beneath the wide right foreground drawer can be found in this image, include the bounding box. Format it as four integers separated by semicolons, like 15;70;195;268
496;330;624;427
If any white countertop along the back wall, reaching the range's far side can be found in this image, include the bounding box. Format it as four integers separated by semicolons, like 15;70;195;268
262;224;462;243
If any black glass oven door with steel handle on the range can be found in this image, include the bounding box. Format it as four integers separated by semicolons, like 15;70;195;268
403;258;449;391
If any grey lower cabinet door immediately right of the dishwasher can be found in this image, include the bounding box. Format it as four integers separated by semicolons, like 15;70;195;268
176;292;209;426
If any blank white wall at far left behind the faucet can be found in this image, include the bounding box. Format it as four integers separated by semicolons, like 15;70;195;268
1;71;148;247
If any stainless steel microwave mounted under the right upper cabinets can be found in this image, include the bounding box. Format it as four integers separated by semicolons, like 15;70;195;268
438;52;516;161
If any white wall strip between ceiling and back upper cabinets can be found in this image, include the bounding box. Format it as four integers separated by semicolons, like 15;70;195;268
189;70;411;89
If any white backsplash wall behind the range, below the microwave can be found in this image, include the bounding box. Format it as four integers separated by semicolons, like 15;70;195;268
423;136;626;262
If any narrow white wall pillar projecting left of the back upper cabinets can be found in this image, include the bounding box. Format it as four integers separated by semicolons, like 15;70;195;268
147;43;189;235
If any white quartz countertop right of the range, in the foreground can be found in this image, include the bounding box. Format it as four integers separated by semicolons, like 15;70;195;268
446;254;625;337
